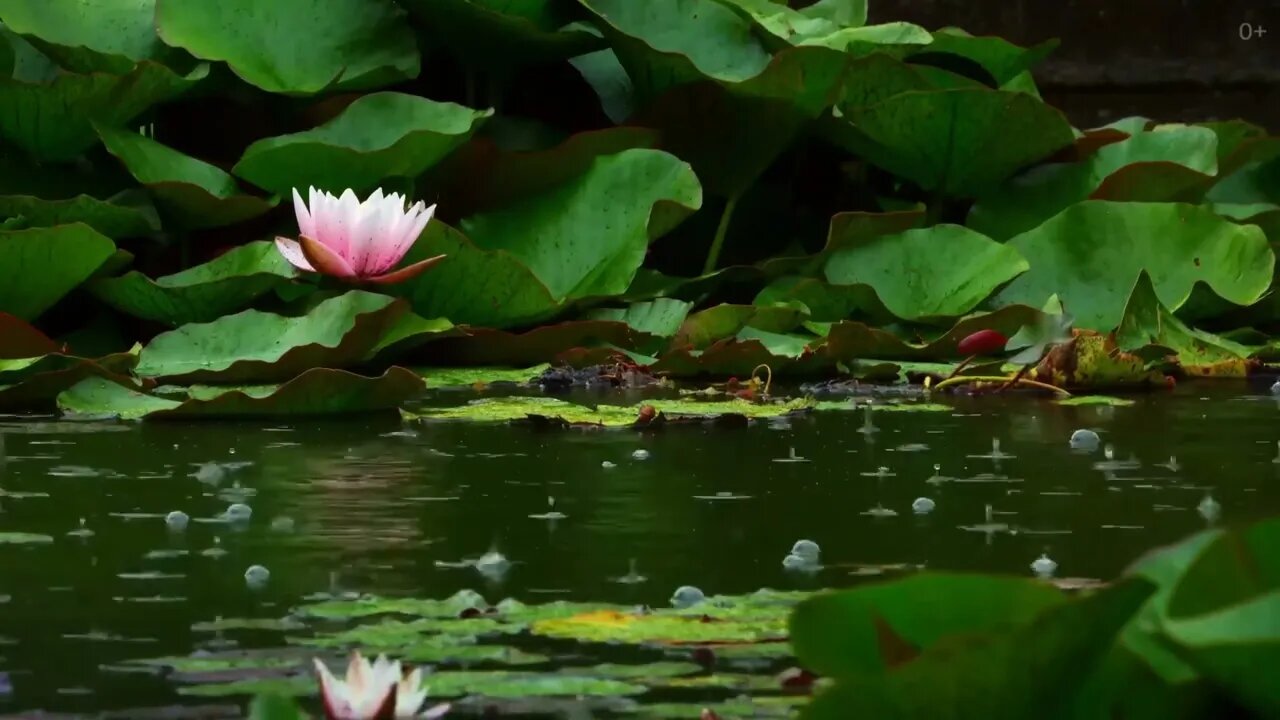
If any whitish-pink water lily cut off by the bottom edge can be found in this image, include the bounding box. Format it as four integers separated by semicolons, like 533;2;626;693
314;652;449;720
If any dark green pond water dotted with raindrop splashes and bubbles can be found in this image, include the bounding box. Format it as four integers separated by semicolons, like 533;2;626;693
0;386;1280;717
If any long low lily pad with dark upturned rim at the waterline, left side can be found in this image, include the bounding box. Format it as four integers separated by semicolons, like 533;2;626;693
58;366;424;420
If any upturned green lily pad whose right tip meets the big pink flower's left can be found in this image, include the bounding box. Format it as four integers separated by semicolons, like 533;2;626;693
88;242;297;327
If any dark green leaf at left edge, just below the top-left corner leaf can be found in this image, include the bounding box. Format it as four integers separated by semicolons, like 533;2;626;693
0;60;209;160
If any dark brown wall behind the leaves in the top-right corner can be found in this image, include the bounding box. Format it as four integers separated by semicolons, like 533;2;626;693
868;0;1280;133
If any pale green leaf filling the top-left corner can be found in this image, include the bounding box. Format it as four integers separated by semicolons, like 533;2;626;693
0;0;174;73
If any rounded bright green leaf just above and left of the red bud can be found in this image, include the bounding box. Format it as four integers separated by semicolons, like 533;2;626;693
826;225;1029;320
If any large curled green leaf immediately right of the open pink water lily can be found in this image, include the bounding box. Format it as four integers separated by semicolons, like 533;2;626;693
392;150;701;328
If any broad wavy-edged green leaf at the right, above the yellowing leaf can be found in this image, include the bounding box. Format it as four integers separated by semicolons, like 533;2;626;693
996;200;1275;332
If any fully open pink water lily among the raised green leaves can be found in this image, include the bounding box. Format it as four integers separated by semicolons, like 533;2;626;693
275;187;444;284
